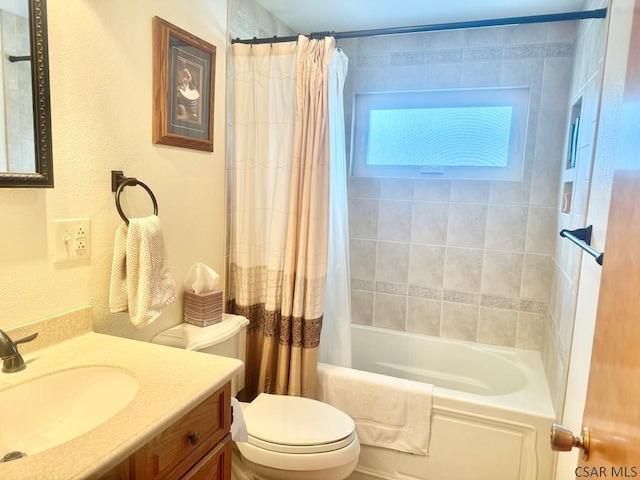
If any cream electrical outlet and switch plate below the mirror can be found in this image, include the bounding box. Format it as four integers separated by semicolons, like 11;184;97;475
52;218;91;263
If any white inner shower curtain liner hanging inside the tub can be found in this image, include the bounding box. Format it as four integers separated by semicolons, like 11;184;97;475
319;48;351;367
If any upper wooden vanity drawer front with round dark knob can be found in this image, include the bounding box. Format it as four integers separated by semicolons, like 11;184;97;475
131;383;231;480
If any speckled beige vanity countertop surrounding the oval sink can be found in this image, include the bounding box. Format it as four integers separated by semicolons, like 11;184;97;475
0;333;243;480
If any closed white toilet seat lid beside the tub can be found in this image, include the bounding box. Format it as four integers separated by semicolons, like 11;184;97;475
243;393;355;453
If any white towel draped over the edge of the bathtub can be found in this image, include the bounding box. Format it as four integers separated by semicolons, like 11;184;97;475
316;363;433;455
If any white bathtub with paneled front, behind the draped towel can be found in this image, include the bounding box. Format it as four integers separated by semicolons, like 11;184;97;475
340;325;555;480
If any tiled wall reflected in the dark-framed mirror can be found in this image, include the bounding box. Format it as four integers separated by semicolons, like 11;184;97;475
0;10;35;172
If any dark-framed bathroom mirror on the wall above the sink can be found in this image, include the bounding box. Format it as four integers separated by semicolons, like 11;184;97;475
0;0;53;187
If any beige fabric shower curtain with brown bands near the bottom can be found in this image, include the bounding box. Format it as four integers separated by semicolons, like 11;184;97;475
228;36;334;399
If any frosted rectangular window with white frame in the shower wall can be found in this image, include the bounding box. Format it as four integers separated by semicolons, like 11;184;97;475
351;87;529;180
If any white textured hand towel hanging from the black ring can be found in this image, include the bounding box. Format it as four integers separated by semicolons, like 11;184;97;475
109;215;176;329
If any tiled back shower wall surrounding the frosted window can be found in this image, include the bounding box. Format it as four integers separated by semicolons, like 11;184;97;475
338;22;577;350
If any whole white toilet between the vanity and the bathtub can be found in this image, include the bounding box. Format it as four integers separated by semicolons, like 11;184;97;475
152;314;360;480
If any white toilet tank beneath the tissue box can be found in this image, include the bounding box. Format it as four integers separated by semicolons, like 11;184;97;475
151;313;249;396
